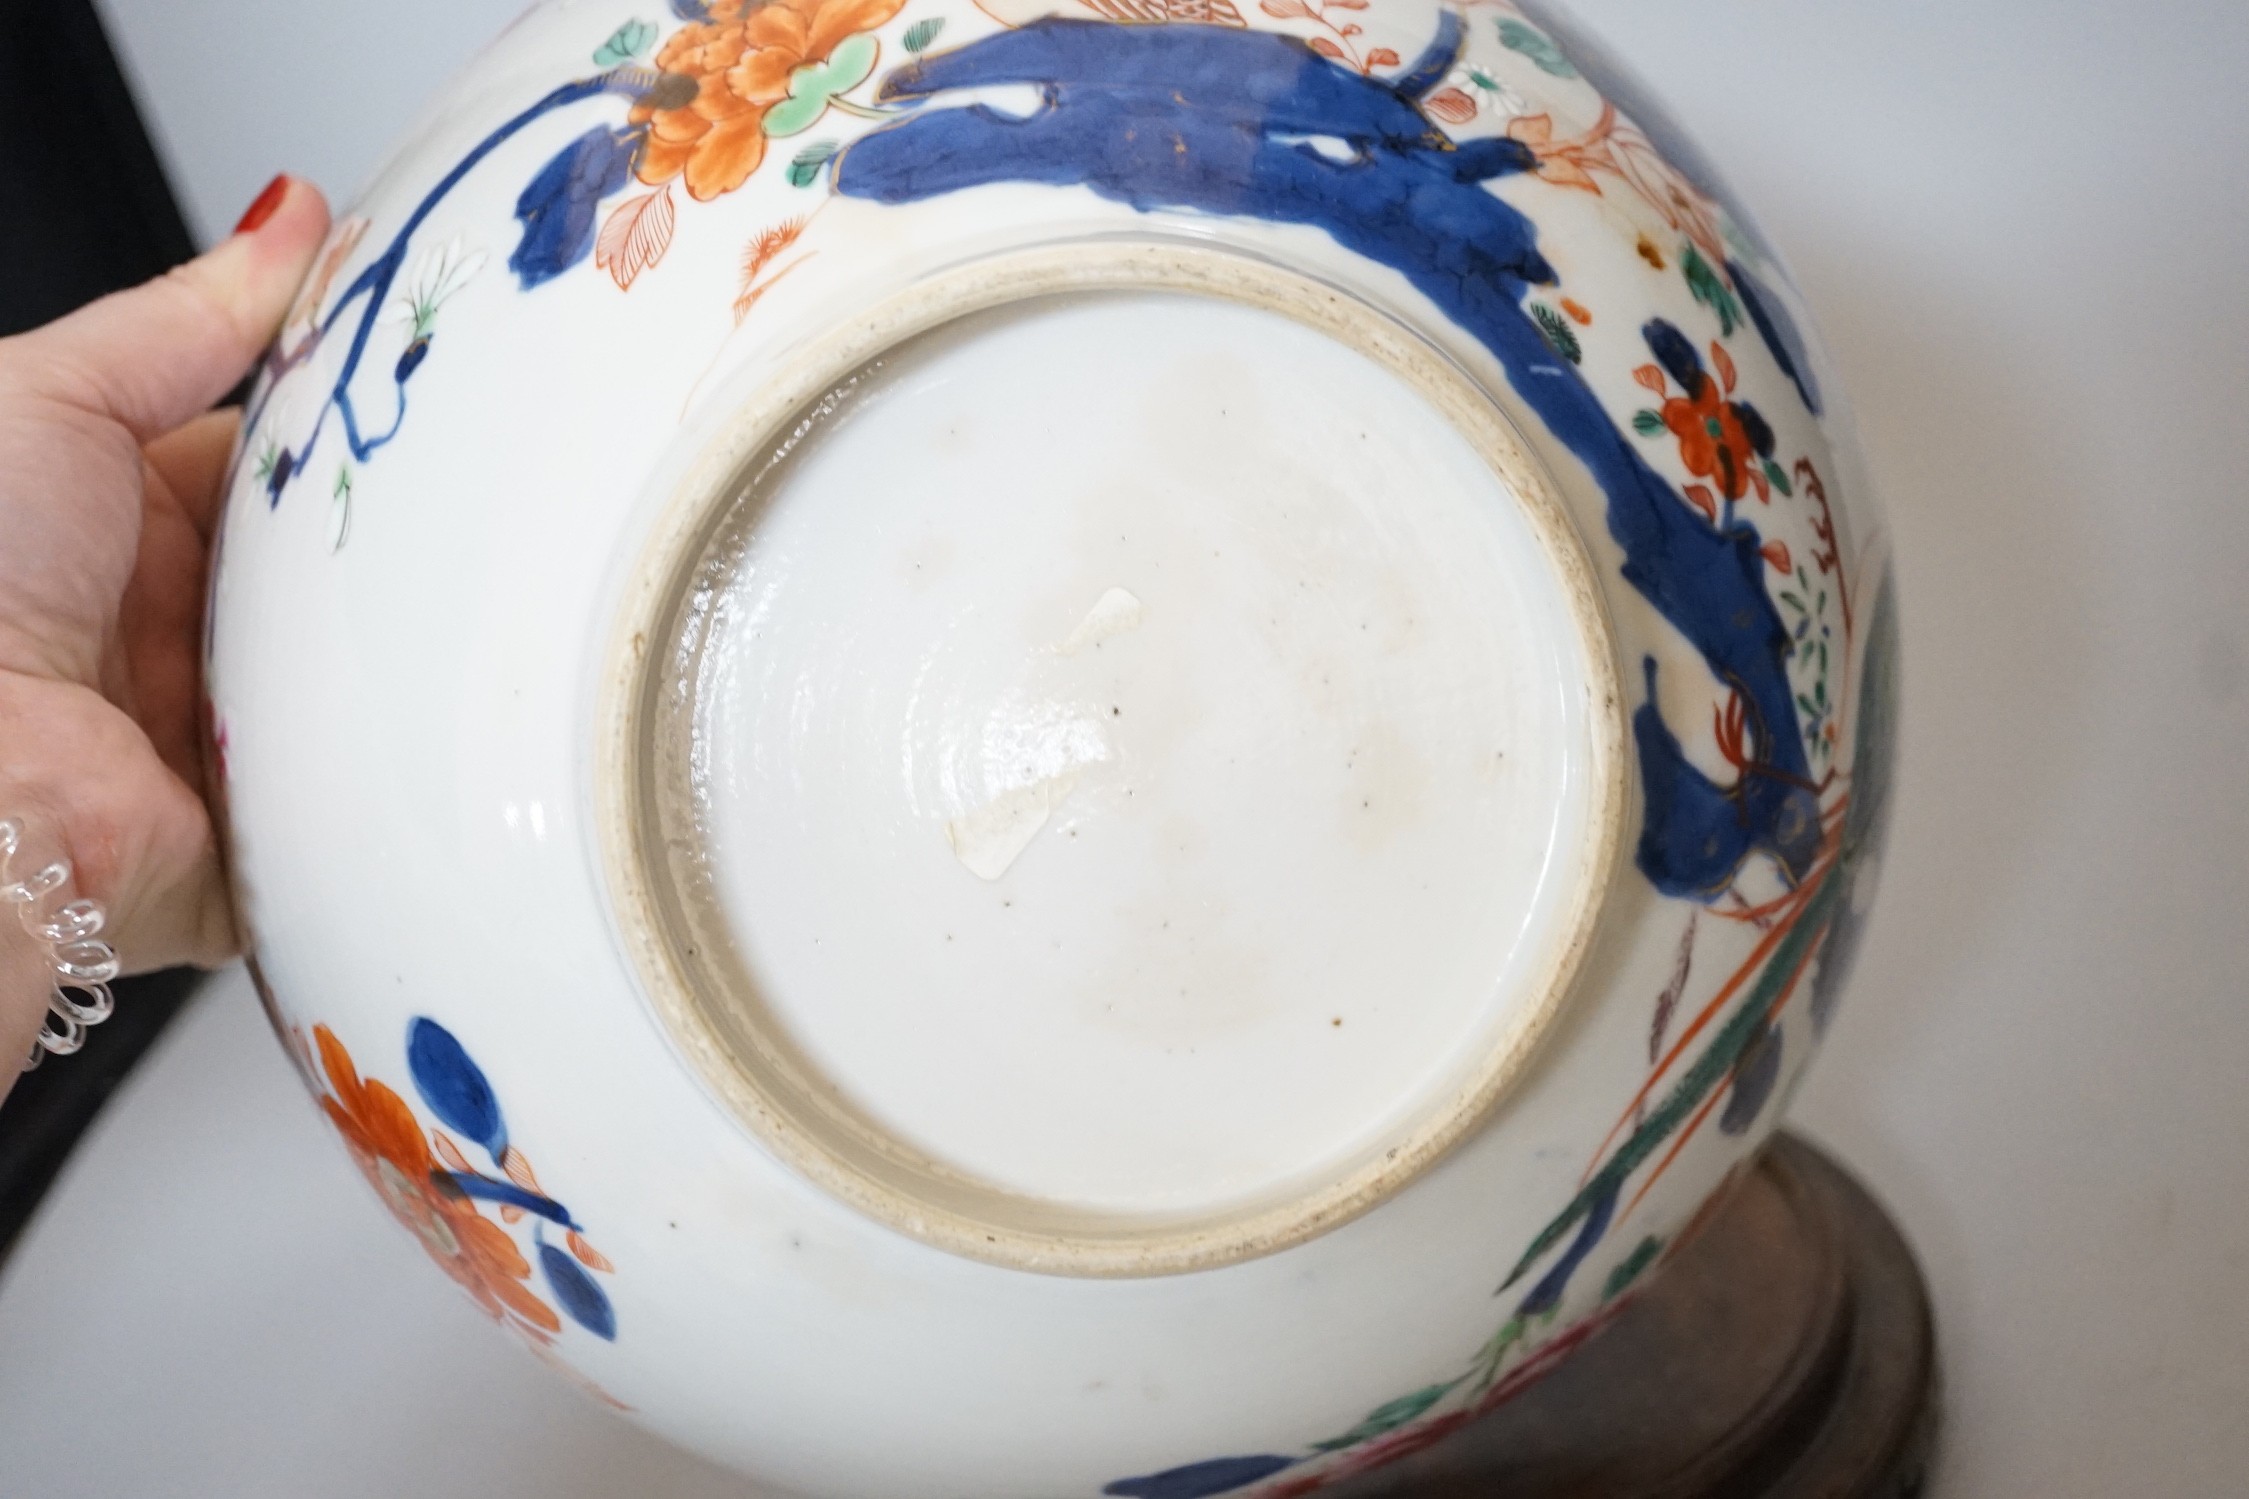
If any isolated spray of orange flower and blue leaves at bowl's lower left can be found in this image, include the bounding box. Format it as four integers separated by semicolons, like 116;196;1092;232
306;1018;616;1346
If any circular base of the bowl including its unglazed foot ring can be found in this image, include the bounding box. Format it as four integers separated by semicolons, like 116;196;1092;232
609;245;1622;1274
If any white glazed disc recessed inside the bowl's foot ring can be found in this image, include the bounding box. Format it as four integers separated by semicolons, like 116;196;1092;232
695;294;1590;1214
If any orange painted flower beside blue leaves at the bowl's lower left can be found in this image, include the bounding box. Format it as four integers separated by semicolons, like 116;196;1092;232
313;1025;562;1342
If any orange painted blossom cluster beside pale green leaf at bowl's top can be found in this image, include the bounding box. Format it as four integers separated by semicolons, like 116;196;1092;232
630;0;904;202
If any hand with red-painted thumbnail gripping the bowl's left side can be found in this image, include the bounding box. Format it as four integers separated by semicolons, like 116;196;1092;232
0;178;328;1097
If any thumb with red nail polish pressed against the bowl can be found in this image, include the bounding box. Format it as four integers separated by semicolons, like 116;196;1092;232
0;178;328;443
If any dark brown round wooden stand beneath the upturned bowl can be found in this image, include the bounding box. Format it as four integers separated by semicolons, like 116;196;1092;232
1334;1135;1936;1499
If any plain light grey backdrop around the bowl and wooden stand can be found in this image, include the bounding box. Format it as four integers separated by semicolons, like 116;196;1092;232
0;0;2249;1499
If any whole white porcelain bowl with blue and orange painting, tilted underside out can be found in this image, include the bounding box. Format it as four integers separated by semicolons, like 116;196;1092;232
209;0;1896;1499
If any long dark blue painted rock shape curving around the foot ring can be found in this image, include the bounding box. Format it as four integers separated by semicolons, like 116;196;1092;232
834;13;1819;899
